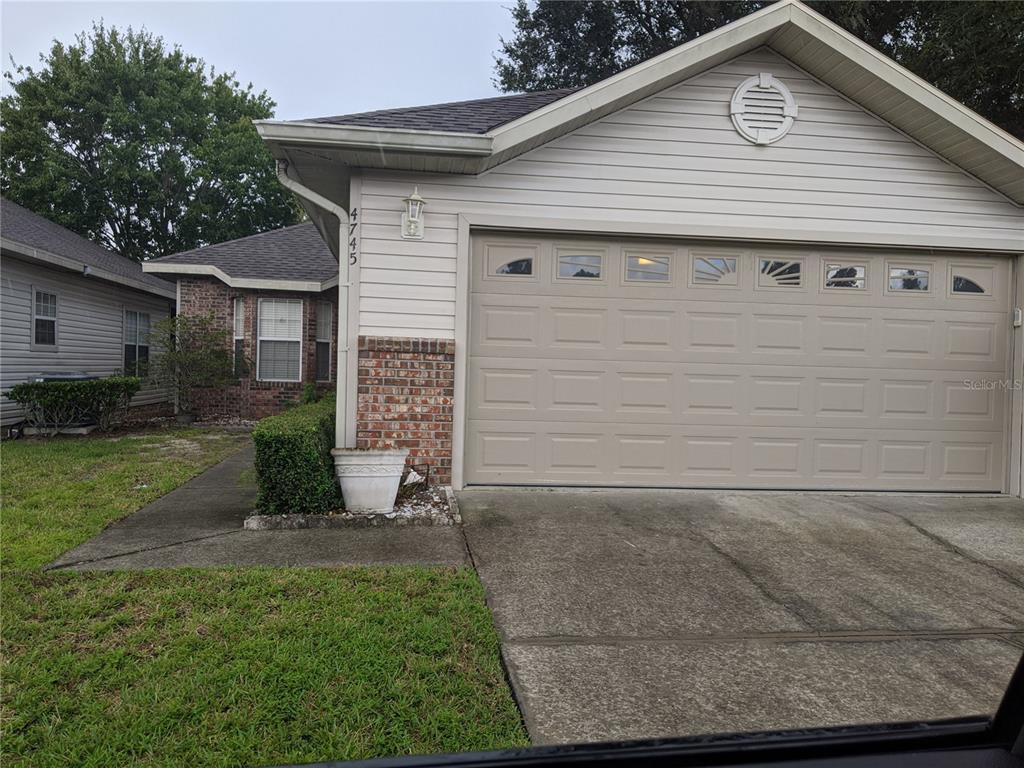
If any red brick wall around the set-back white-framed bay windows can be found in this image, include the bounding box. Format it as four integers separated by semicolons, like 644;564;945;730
178;278;338;419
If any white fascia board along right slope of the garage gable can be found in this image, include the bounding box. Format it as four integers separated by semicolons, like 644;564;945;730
791;2;1024;169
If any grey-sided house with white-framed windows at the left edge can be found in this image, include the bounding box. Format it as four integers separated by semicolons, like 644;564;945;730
0;200;174;428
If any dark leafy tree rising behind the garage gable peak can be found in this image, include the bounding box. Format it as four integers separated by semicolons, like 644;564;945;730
495;0;1024;137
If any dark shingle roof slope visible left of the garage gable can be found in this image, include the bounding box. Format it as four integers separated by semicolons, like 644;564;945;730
302;88;578;133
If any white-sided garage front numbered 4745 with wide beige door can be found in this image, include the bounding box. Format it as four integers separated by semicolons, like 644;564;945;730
251;0;1024;494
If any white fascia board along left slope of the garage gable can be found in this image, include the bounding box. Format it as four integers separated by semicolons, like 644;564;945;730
486;0;794;154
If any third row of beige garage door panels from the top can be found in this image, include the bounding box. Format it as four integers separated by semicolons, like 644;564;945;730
468;357;1008;431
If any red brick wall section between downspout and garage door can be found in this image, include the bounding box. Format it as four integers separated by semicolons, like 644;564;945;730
356;336;455;483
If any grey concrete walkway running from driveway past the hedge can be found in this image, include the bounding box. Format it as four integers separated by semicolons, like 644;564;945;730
49;446;468;570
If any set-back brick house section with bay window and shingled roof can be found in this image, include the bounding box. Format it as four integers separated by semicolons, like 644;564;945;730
143;222;338;419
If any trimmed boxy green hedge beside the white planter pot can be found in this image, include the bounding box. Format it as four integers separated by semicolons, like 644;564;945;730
253;398;342;515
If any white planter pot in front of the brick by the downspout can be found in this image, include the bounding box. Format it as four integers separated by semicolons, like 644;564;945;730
331;449;409;515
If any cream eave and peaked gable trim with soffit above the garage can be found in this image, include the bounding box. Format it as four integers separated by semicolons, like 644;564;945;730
257;0;1024;204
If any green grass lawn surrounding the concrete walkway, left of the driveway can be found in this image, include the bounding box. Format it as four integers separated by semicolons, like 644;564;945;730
0;430;527;766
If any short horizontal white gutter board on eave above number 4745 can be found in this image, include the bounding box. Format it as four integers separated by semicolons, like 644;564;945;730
253;120;493;158
